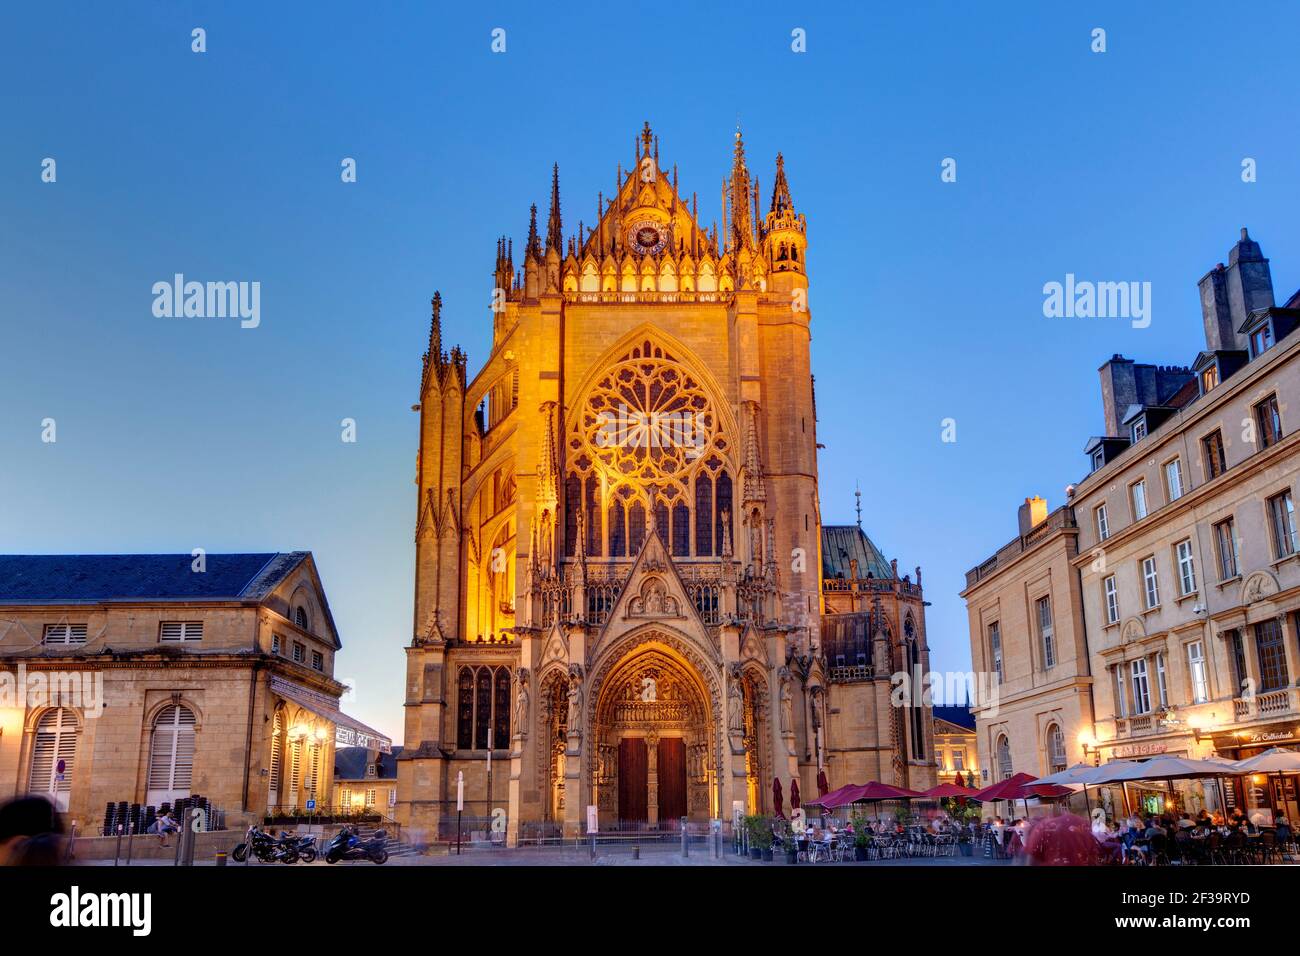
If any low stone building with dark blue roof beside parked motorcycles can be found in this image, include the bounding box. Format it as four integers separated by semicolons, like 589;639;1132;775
0;551;390;834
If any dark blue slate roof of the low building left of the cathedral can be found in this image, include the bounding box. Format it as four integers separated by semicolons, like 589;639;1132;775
0;551;311;604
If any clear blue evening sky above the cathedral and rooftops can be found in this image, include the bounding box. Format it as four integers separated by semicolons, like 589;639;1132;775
0;1;1300;739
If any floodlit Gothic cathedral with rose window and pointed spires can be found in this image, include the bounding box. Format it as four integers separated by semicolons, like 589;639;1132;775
397;124;935;840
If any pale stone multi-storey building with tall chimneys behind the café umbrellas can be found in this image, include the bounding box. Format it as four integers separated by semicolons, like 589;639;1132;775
963;229;1300;819
